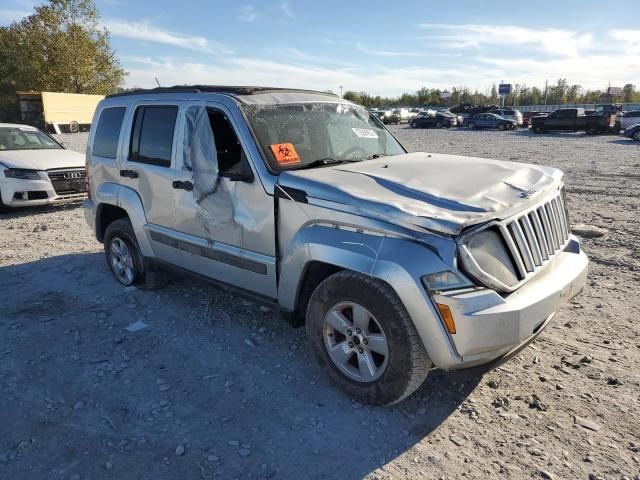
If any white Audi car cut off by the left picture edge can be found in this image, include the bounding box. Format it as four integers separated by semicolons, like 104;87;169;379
0;123;86;210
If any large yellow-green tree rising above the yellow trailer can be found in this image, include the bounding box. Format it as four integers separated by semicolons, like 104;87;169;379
0;0;126;120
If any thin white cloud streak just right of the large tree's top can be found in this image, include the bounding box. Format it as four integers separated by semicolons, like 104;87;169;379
103;19;233;54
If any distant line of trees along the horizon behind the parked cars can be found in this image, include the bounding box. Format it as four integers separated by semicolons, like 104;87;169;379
344;78;640;107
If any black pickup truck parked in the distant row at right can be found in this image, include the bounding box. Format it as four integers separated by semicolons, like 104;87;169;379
531;108;615;135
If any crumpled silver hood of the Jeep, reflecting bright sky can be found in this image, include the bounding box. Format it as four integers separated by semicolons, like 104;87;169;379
276;153;562;235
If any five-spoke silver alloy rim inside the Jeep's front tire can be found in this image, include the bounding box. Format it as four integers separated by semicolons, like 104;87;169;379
323;302;389;382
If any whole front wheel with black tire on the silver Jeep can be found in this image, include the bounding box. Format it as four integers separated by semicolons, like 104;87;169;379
306;271;431;405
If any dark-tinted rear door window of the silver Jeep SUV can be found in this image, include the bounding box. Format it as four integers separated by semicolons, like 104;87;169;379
129;105;178;167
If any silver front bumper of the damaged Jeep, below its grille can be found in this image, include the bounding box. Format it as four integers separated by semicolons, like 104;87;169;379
433;236;589;368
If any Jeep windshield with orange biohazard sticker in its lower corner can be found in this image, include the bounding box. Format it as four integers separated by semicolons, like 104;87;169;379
242;103;405;171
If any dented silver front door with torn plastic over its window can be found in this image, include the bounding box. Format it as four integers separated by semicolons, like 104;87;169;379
168;104;277;298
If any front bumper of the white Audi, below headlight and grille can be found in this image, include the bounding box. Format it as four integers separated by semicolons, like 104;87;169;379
0;178;87;207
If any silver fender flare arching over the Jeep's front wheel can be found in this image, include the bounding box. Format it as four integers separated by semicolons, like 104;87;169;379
278;224;460;365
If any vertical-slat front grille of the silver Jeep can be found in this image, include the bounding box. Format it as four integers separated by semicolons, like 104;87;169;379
500;189;571;280
